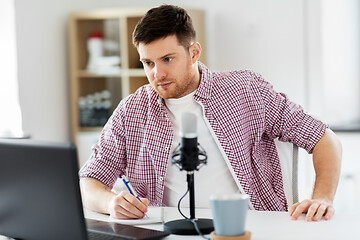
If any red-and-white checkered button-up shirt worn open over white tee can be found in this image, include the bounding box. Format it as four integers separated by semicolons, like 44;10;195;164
79;62;327;211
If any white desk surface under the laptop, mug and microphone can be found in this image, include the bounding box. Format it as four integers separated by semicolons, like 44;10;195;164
85;208;360;240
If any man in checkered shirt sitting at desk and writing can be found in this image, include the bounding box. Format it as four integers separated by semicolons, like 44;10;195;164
80;5;341;221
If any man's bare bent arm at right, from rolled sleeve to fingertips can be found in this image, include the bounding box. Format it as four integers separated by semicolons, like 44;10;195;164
289;129;342;221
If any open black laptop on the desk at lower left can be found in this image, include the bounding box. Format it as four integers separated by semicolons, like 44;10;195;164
0;139;169;240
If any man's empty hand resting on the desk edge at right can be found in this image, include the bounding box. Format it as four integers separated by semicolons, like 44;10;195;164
289;199;335;222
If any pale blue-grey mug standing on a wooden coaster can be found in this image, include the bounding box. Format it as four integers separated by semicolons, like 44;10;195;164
210;194;249;236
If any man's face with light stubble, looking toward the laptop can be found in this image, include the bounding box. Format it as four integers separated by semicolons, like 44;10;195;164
138;35;200;99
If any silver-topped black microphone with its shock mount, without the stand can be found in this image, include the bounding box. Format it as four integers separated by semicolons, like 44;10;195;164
172;112;207;172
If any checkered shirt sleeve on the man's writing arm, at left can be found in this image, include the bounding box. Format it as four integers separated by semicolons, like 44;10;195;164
79;100;126;188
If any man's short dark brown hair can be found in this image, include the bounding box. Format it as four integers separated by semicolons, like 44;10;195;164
133;5;196;48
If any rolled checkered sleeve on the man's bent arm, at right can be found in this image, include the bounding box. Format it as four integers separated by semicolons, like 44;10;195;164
256;71;328;153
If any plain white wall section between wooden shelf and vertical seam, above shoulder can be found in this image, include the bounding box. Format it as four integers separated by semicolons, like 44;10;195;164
208;0;306;105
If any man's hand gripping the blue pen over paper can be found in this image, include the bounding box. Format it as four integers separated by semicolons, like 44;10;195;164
108;191;149;219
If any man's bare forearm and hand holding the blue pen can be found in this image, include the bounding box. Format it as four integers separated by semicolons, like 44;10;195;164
80;178;149;219
